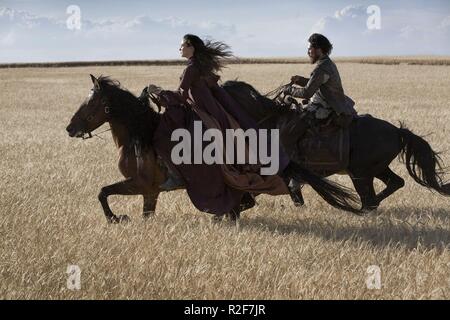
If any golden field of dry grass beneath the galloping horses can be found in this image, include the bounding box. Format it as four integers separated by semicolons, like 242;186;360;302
0;63;450;299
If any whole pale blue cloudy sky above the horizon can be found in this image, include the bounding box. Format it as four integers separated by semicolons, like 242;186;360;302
0;0;450;62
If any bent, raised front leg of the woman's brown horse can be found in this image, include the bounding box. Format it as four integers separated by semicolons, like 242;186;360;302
98;178;146;223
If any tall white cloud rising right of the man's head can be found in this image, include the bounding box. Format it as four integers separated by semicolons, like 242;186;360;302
311;5;450;56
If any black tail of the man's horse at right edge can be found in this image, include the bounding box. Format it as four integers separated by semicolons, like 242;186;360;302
399;125;450;196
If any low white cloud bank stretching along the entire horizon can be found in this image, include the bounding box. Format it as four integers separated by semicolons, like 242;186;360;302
0;5;450;62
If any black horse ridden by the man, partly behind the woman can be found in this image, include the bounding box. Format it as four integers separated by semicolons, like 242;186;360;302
223;81;450;211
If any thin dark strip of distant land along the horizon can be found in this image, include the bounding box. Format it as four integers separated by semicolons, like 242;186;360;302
0;56;450;68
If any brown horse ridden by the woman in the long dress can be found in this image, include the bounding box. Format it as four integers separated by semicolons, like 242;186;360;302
66;75;358;223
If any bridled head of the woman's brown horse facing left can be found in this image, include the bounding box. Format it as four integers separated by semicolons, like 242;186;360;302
66;74;110;138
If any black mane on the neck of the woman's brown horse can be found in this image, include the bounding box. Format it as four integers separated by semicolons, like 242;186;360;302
97;76;160;147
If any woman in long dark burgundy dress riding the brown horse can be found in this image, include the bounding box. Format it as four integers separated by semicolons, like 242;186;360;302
149;34;289;214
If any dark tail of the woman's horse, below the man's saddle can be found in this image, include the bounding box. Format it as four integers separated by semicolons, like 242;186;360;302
285;162;362;214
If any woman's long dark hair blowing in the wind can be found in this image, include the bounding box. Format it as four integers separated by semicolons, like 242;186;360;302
183;34;233;75
